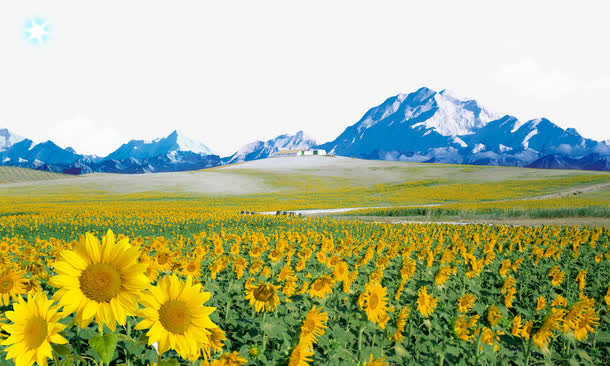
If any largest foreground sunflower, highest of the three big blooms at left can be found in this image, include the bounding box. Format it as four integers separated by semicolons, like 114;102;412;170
49;230;148;331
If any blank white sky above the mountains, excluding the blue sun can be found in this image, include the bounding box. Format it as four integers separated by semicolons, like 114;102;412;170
0;0;610;156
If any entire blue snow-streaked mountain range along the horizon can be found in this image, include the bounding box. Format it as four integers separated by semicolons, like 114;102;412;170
0;87;610;174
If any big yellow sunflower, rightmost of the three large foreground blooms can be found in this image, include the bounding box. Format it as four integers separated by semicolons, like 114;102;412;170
135;275;218;358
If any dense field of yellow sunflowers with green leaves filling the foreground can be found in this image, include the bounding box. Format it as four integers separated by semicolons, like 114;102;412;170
0;202;610;366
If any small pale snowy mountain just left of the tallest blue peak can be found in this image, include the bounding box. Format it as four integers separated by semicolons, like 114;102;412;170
222;131;316;164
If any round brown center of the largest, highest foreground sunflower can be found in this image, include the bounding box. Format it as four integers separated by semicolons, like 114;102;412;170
79;263;123;302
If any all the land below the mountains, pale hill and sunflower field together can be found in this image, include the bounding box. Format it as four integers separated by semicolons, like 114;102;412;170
0;157;610;366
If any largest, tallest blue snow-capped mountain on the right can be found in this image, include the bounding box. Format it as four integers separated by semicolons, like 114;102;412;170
319;87;610;169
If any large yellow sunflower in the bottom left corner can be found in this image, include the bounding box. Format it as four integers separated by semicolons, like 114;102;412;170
0;292;68;366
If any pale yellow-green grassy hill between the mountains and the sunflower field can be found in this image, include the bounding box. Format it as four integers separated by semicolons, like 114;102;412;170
0;157;610;211
